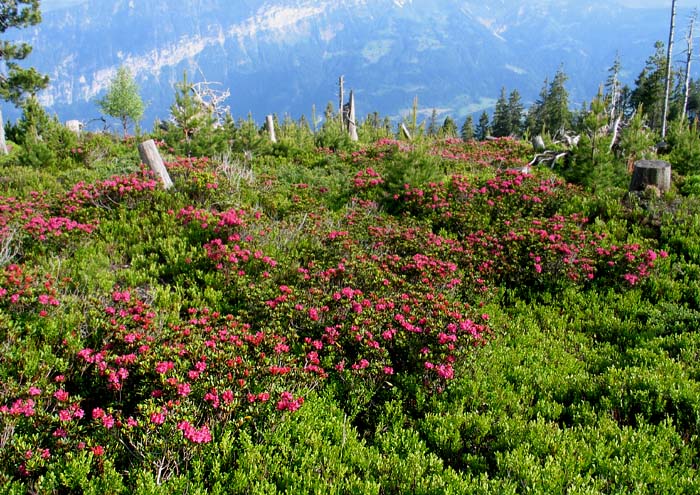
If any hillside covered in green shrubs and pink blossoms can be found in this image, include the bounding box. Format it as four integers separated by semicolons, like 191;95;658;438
0;135;700;494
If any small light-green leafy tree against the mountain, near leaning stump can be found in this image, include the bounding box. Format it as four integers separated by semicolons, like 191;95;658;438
97;66;144;136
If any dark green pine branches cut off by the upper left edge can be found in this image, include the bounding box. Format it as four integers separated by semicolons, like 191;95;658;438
0;0;49;105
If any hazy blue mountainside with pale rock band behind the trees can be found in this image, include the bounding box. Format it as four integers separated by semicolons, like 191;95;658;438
5;0;694;128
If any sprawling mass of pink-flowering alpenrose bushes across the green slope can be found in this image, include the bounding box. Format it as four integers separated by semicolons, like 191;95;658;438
0;137;665;491
